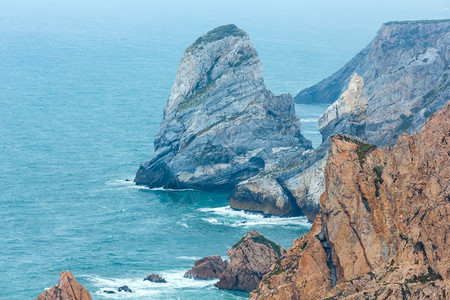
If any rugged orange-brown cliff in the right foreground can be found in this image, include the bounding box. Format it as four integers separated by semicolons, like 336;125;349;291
250;103;450;299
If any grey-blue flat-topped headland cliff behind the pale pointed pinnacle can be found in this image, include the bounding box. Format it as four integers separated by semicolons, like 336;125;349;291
295;20;450;146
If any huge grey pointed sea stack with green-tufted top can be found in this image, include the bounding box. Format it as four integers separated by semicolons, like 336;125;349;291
135;25;311;189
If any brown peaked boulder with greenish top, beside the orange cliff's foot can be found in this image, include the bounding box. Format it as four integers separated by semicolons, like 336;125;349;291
215;230;285;292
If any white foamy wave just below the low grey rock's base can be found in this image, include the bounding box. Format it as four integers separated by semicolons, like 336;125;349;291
198;206;311;227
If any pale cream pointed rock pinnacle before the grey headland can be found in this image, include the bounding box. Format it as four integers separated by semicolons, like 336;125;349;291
319;73;367;142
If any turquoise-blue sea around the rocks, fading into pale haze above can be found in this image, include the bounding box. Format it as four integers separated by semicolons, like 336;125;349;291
0;0;448;299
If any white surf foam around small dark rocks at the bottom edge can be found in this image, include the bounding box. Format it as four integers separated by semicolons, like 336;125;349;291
86;270;217;299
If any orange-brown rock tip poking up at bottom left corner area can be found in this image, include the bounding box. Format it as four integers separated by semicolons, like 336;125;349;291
36;271;92;300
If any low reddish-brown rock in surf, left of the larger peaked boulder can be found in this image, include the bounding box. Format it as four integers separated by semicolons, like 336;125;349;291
184;255;228;280
